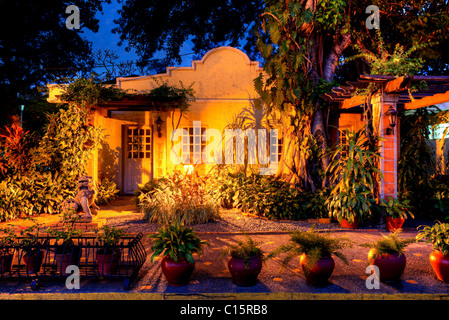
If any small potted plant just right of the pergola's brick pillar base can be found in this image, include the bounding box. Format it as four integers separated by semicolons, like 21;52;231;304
379;197;414;232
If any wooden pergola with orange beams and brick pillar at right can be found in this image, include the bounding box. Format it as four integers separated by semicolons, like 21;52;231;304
324;75;449;202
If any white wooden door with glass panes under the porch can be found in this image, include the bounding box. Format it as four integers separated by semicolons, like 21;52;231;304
123;126;153;194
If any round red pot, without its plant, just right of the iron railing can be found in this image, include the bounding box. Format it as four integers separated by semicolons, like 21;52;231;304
161;256;195;287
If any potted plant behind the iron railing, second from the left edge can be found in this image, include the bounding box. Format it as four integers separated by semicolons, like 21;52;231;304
19;218;44;273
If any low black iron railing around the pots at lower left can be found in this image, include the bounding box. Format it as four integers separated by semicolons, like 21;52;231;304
0;233;147;290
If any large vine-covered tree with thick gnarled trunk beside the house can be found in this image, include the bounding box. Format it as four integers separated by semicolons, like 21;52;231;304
255;0;449;191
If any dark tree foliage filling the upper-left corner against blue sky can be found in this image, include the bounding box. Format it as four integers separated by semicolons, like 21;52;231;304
0;0;110;122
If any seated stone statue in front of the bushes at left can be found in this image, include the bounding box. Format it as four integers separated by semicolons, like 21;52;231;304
62;176;100;222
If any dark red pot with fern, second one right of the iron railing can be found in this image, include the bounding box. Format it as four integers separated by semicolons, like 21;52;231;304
222;236;264;287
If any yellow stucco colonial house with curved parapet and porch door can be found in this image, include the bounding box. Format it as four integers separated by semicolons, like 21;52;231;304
48;47;279;194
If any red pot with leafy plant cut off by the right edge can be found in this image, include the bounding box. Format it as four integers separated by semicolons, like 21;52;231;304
416;221;449;282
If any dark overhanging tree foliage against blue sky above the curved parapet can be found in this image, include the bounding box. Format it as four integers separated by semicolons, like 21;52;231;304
114;0;263;69
